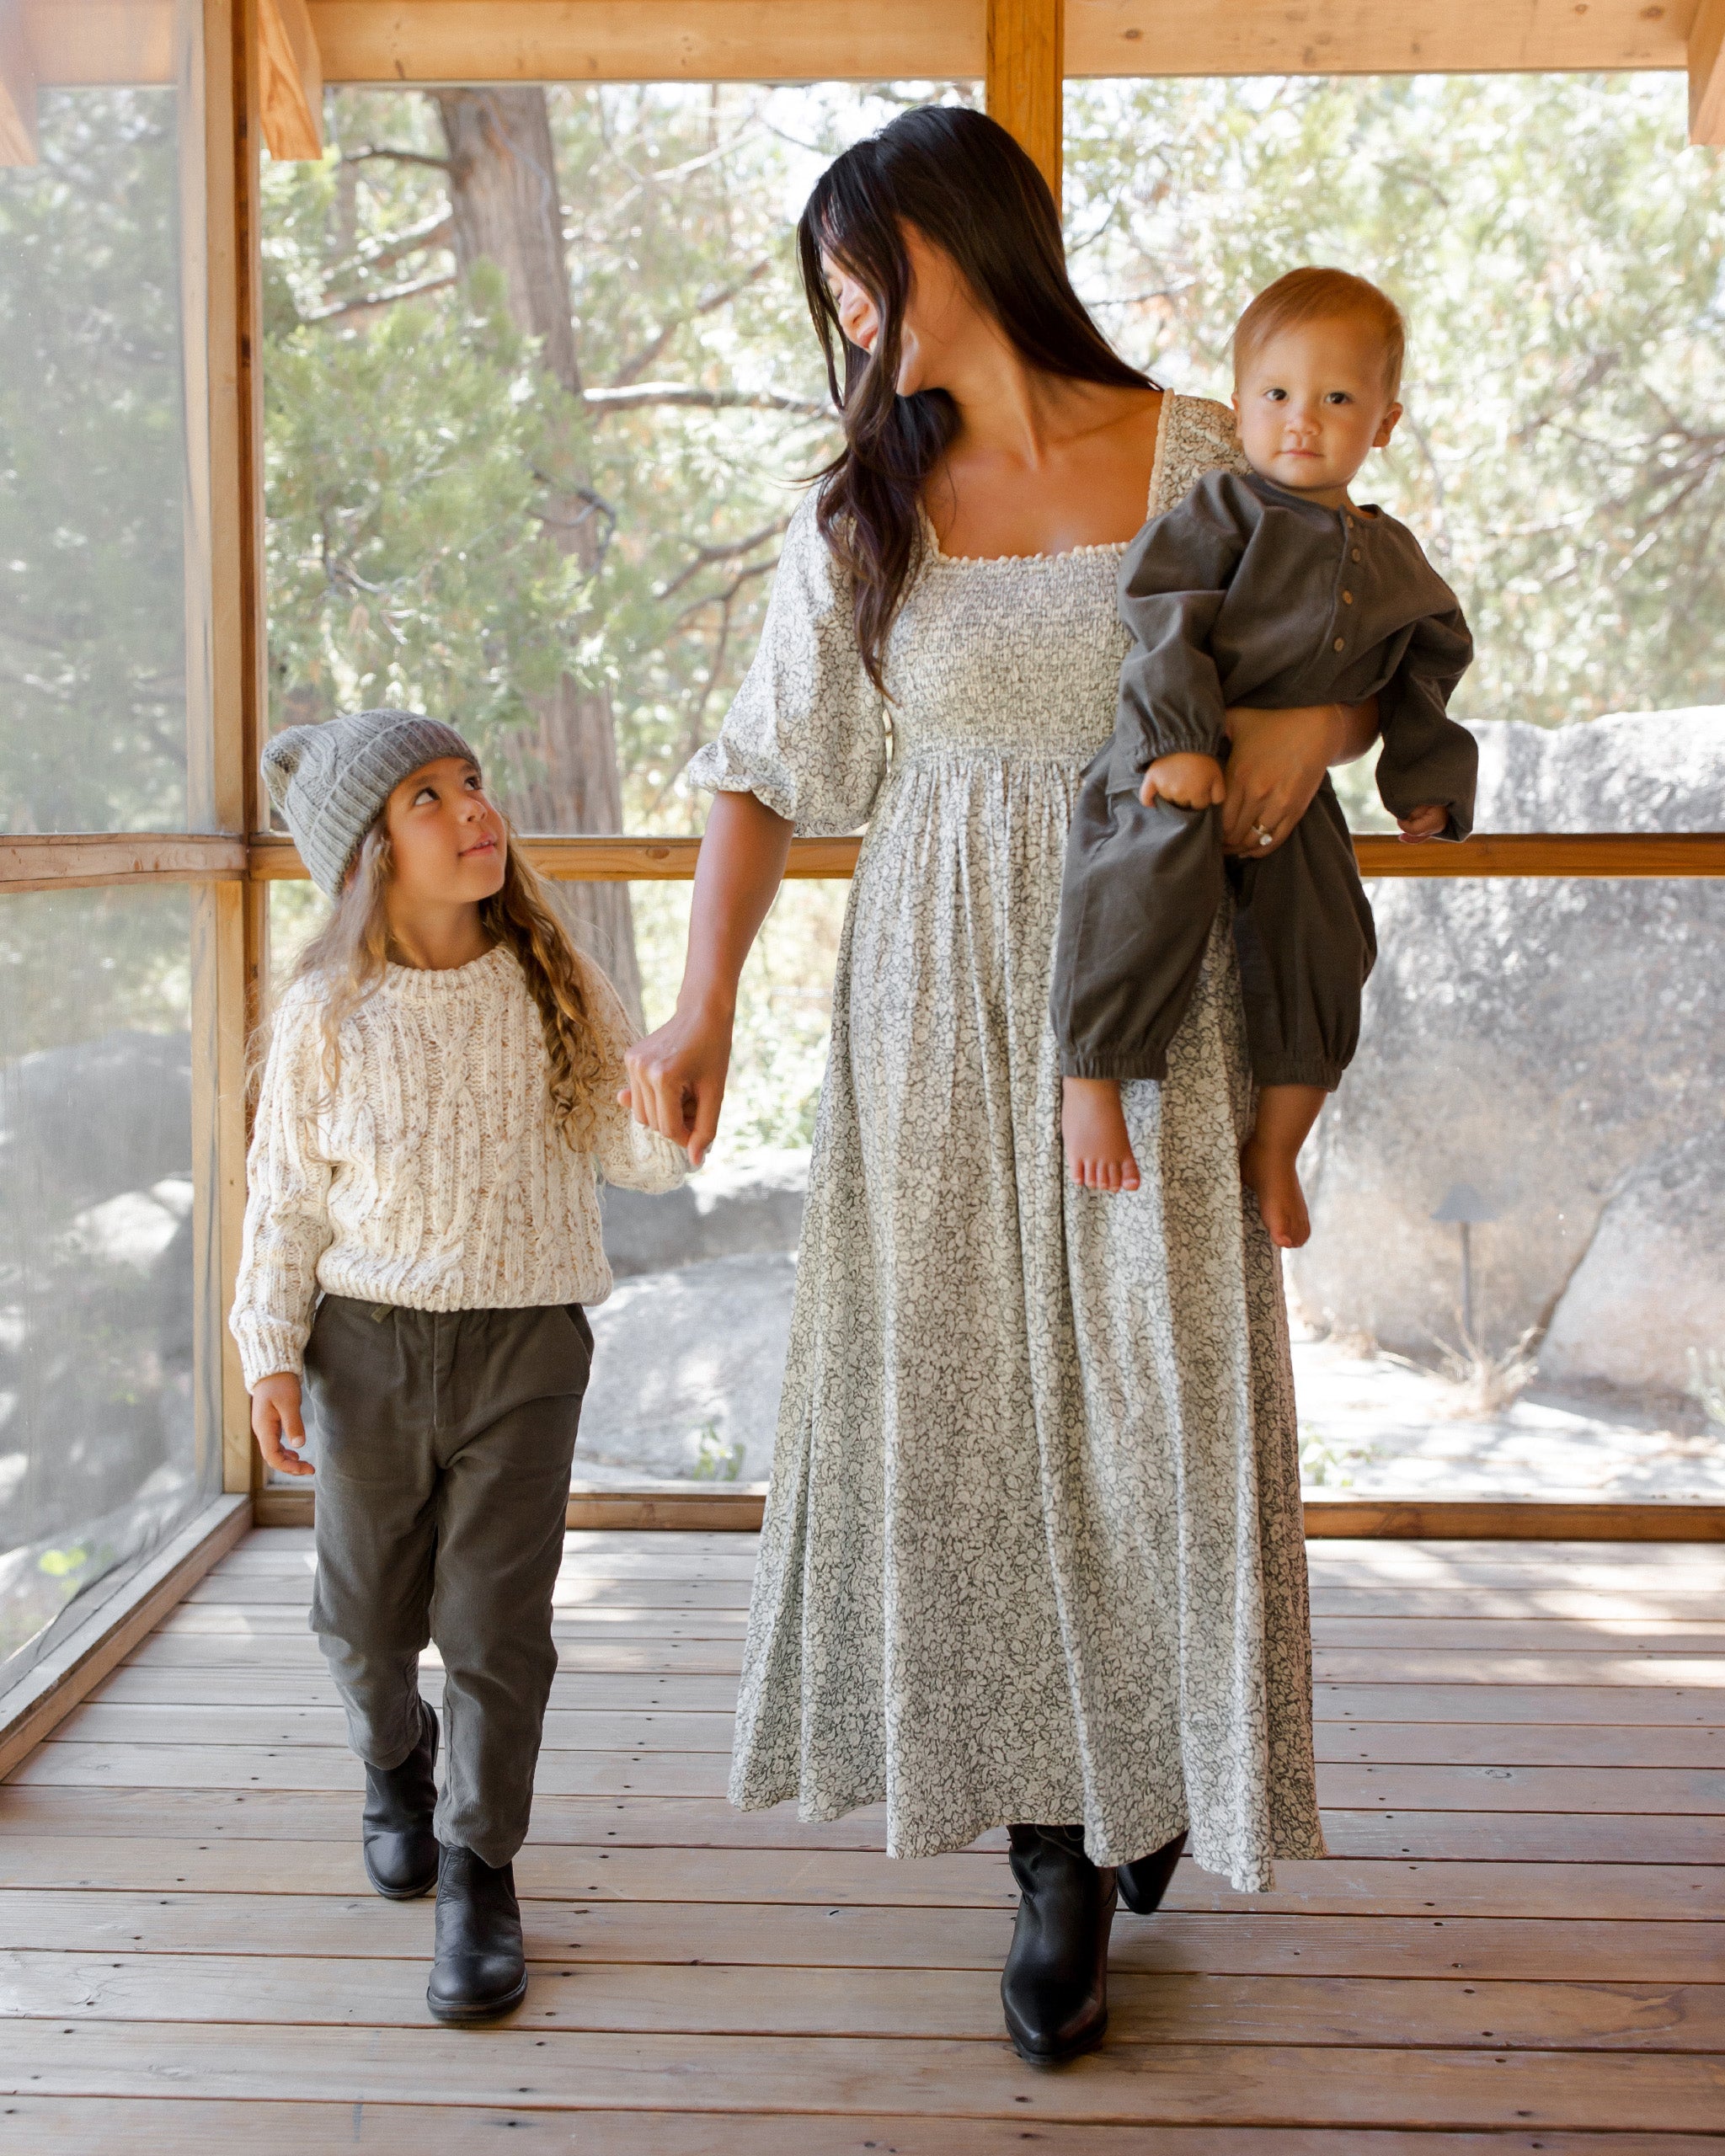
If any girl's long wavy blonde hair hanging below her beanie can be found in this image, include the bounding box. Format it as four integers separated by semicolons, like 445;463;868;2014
293;815;623;1151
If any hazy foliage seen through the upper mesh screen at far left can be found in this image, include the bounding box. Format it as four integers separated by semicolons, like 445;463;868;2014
0;88;199;832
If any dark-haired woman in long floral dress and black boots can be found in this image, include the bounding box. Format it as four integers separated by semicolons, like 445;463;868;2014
630;108;1374;2061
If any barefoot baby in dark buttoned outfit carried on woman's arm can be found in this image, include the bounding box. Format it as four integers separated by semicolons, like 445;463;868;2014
1052;270;1477;1248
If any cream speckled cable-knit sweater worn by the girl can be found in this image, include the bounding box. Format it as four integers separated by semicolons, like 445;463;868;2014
228;948;688;1386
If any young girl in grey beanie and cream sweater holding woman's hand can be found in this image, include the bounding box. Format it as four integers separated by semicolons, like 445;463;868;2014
231;712;686;2022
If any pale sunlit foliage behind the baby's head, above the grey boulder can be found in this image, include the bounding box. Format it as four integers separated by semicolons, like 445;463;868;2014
1067;76;1725;724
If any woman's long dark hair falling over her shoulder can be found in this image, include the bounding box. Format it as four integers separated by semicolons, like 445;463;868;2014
796;105;1156;690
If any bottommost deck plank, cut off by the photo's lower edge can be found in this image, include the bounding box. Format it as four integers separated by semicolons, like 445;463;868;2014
7;2095;1718;2156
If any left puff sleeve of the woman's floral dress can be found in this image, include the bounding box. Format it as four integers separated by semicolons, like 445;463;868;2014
684;492;886;839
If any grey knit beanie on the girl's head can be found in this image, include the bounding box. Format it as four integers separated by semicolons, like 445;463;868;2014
263;712;478;899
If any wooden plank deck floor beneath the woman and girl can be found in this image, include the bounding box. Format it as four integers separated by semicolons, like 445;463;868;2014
0;1529;1725;2156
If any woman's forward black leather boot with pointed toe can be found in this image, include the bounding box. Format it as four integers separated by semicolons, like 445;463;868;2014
1001;1826;1115;2065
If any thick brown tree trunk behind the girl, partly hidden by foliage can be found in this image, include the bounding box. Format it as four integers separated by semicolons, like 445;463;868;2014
431;84;640;1024
